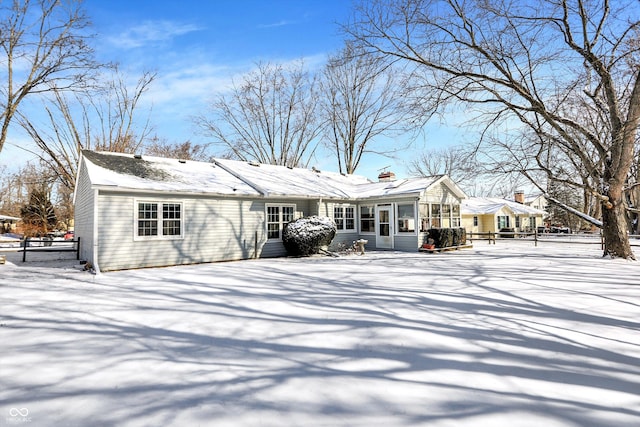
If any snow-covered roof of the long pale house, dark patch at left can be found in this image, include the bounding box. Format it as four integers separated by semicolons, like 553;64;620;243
82;150;466;200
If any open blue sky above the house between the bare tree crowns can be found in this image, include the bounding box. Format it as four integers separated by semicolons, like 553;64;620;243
0;0;455;179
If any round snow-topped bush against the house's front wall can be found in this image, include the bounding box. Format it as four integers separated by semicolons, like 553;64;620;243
282;216;336;256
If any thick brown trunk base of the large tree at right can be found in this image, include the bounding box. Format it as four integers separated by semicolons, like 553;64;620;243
602;185;636;260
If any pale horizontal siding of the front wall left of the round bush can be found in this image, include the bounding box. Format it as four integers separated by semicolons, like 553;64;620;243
98;193;316;271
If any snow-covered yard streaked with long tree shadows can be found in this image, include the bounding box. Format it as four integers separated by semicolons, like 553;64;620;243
0;241;640;427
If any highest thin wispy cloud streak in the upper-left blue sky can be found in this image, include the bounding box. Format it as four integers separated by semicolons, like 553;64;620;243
108;20;202;49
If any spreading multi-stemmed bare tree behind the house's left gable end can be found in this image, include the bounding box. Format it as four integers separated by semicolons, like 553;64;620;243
19;67;156;189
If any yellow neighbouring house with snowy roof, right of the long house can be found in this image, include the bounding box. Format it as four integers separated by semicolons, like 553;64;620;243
462;197;546;233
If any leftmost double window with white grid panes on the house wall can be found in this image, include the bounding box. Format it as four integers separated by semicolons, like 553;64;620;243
136;202;182;239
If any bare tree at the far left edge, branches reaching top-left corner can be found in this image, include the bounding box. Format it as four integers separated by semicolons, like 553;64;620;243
0;0;94;156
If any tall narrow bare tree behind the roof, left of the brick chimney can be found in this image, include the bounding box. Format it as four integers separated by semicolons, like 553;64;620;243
320;42;409;174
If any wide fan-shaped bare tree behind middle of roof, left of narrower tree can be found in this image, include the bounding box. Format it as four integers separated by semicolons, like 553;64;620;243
196;62;322;167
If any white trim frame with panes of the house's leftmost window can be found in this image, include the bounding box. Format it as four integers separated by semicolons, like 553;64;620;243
133;199;184;241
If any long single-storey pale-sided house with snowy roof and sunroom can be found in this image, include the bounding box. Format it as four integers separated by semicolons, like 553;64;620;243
74;150;466;271
